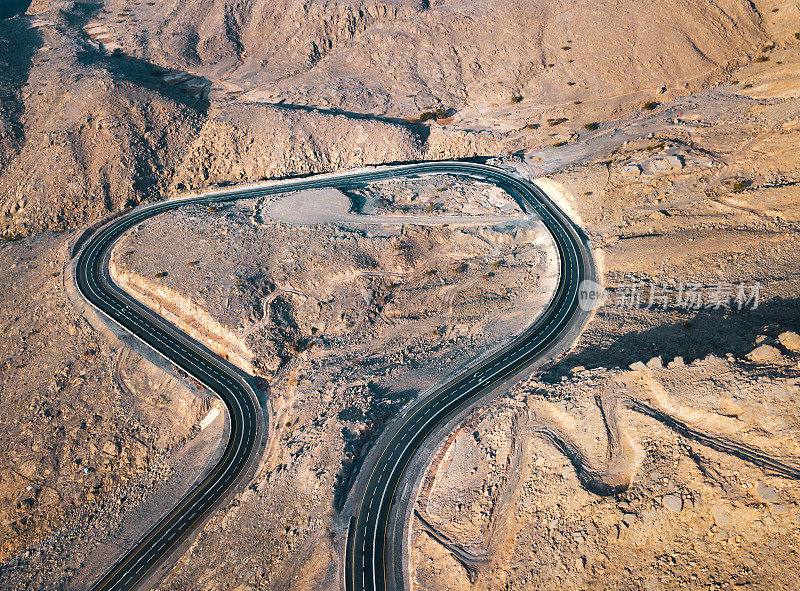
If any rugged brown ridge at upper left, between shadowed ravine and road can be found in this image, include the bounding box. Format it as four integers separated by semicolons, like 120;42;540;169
0;4;428;237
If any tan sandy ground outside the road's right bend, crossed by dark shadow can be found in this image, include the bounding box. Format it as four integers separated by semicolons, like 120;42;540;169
412;52;800;590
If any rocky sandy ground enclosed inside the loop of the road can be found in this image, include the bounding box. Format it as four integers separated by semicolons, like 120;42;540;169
103;175;556;588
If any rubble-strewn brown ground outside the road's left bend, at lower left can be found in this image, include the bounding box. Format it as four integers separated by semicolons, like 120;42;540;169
0;234;226;589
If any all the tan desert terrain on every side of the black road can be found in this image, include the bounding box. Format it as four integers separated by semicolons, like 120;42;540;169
0;0;800;590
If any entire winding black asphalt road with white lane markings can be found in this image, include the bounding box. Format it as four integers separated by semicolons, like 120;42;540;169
75;162;594;591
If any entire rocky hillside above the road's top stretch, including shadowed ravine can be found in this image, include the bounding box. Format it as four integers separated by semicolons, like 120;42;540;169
0;0;786;237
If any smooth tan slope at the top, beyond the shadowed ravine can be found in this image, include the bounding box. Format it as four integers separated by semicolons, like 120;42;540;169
98;0;767;116
